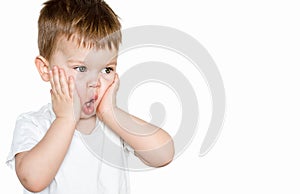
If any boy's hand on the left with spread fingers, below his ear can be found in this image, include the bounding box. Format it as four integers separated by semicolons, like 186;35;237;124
49;66;81;123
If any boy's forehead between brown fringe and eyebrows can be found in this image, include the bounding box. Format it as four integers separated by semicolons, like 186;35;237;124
56;38;118;62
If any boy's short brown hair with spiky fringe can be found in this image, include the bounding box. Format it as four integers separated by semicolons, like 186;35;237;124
38;0;122;59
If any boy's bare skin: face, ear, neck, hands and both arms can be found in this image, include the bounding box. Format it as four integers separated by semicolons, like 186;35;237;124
16;38;174;192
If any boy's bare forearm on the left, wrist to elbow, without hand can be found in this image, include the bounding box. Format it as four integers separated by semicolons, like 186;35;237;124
15;118;75;192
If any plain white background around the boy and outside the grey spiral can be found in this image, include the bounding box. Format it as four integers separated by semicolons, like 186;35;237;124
0;0;300;194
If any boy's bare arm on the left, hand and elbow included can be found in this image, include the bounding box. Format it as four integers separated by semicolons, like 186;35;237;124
15;67;79;192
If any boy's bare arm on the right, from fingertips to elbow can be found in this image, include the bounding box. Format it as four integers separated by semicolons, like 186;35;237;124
97;75;174;167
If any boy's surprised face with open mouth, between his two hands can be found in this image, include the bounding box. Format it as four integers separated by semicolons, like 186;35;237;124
49;36;118;118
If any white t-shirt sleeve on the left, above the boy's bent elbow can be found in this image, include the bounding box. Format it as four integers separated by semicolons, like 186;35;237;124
6;115;43;169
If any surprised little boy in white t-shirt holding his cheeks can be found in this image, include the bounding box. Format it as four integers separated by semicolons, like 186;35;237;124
7;0;174;194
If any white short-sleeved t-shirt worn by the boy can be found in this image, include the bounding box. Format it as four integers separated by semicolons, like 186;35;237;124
6;104;129;194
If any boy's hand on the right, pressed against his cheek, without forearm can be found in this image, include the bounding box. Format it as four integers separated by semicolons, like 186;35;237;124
96;74;120;121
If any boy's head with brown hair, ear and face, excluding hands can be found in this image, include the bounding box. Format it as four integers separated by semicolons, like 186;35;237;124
35;0;121;118
